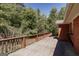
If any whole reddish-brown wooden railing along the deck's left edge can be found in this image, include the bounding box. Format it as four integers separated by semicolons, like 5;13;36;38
0;33;51;55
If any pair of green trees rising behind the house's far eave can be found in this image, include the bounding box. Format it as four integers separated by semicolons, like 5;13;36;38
47;7;65;35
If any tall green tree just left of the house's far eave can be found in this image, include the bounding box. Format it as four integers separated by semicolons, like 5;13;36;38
47;7;57;35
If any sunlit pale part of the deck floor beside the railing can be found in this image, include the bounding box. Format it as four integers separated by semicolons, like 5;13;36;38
9;37;57;56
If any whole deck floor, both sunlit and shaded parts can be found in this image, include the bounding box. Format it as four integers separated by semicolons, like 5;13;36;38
8;37;78;56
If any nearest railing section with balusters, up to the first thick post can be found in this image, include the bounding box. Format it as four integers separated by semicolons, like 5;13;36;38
0;37;23;55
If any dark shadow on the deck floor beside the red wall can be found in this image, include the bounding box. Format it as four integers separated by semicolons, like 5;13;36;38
53;41;77;56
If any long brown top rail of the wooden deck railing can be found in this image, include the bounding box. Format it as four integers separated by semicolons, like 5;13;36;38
0;32;51;41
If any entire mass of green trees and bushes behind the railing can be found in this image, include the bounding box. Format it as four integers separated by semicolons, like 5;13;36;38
0;3;64;36
